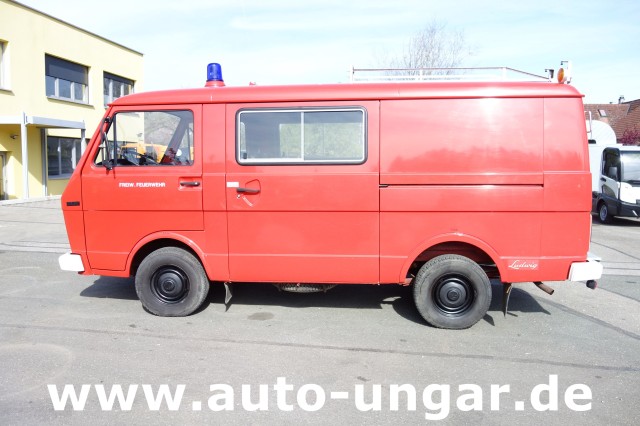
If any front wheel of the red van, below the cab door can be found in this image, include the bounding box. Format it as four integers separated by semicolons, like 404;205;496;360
136;247;209;317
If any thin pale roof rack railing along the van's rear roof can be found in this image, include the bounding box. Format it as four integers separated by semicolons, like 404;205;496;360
349;67;553;83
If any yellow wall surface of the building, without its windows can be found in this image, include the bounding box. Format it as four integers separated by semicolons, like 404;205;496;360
0;0;143;198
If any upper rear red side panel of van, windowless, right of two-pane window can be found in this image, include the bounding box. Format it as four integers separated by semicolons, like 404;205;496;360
380;98;543;185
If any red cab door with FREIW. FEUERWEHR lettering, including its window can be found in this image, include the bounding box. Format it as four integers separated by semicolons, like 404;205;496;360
82;105;204;271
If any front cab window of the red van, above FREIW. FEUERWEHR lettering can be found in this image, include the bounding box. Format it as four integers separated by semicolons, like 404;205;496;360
94;111;194;166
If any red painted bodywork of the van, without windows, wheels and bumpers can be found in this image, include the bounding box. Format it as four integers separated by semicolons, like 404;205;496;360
63;82;591;283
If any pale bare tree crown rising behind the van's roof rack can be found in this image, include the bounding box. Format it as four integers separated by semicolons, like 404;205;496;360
380;21;472;74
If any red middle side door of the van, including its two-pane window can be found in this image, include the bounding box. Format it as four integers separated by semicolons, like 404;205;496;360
226;102;379;283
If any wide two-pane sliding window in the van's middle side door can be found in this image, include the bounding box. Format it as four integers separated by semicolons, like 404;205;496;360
236;108;366;164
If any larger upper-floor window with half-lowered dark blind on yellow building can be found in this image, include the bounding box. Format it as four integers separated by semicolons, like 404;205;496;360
44;55;89;103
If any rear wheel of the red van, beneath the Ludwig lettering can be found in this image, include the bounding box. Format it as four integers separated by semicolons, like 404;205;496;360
413;254;491;329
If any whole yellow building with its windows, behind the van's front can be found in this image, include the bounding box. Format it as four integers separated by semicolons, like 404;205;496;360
0;0;143;200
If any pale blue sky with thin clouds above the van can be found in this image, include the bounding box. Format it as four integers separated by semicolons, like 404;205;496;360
20;0;640;103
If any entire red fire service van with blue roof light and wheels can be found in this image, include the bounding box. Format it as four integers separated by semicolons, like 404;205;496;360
60;64;602;329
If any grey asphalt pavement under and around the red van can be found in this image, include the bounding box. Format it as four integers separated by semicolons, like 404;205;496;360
0;199;640;425
